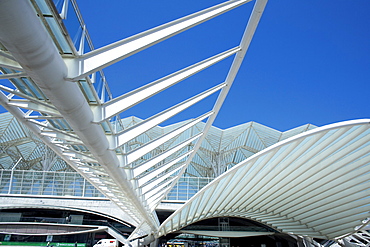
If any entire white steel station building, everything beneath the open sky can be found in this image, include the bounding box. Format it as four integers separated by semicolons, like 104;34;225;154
0;0;370;247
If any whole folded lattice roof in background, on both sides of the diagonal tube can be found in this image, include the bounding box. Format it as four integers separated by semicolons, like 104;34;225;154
0;110;315;178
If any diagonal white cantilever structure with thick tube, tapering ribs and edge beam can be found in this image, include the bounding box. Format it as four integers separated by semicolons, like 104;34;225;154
0;0;266;238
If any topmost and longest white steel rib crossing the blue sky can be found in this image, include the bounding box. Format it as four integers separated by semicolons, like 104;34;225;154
66;0;251;81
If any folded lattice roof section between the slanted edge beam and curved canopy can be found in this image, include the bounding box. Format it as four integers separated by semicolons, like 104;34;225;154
187;122;315;177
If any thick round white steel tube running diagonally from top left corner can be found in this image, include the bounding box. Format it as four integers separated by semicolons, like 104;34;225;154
0;1;158;230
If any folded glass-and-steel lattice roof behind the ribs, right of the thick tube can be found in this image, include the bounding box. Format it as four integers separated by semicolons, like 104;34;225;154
121;117;316;178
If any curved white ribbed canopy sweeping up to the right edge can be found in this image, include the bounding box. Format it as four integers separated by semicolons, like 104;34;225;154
159;119;370;239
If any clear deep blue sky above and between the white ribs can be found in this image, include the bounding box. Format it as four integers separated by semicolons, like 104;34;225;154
42;0;370;131
